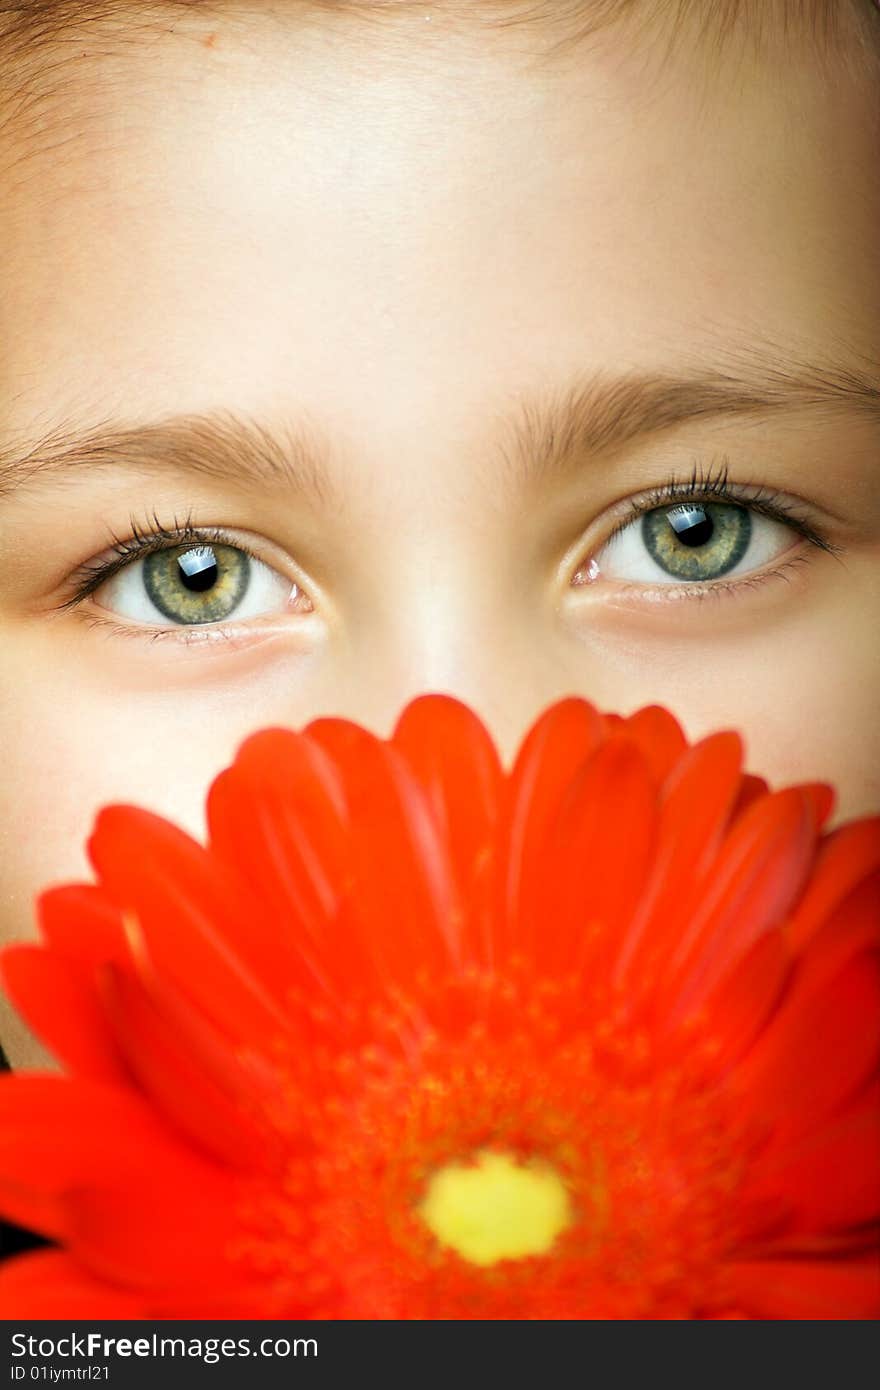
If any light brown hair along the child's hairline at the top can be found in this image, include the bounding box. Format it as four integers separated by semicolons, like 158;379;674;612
0;0;880;158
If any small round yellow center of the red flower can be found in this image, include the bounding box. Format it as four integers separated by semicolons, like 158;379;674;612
418;1152;571;1265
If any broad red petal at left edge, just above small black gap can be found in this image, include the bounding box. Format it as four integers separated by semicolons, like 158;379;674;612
0;1076;241;1290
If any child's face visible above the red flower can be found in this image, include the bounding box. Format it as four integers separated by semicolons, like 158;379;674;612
0;10;880;1061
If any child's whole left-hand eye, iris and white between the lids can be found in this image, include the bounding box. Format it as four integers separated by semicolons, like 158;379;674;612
92;542;299;626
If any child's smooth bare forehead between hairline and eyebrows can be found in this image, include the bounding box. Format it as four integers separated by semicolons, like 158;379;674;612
0;18;880;467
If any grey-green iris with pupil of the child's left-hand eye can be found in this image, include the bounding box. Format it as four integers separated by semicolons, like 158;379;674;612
143;545;250;623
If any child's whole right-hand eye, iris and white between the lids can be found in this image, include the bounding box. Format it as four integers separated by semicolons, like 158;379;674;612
589;500;795;584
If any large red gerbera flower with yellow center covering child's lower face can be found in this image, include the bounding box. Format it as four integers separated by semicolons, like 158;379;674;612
0;695;880;1319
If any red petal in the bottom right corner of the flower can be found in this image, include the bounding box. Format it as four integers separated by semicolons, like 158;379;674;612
726;1255;880;1322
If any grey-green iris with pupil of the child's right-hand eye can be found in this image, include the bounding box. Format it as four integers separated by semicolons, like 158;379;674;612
641;502;752;581
